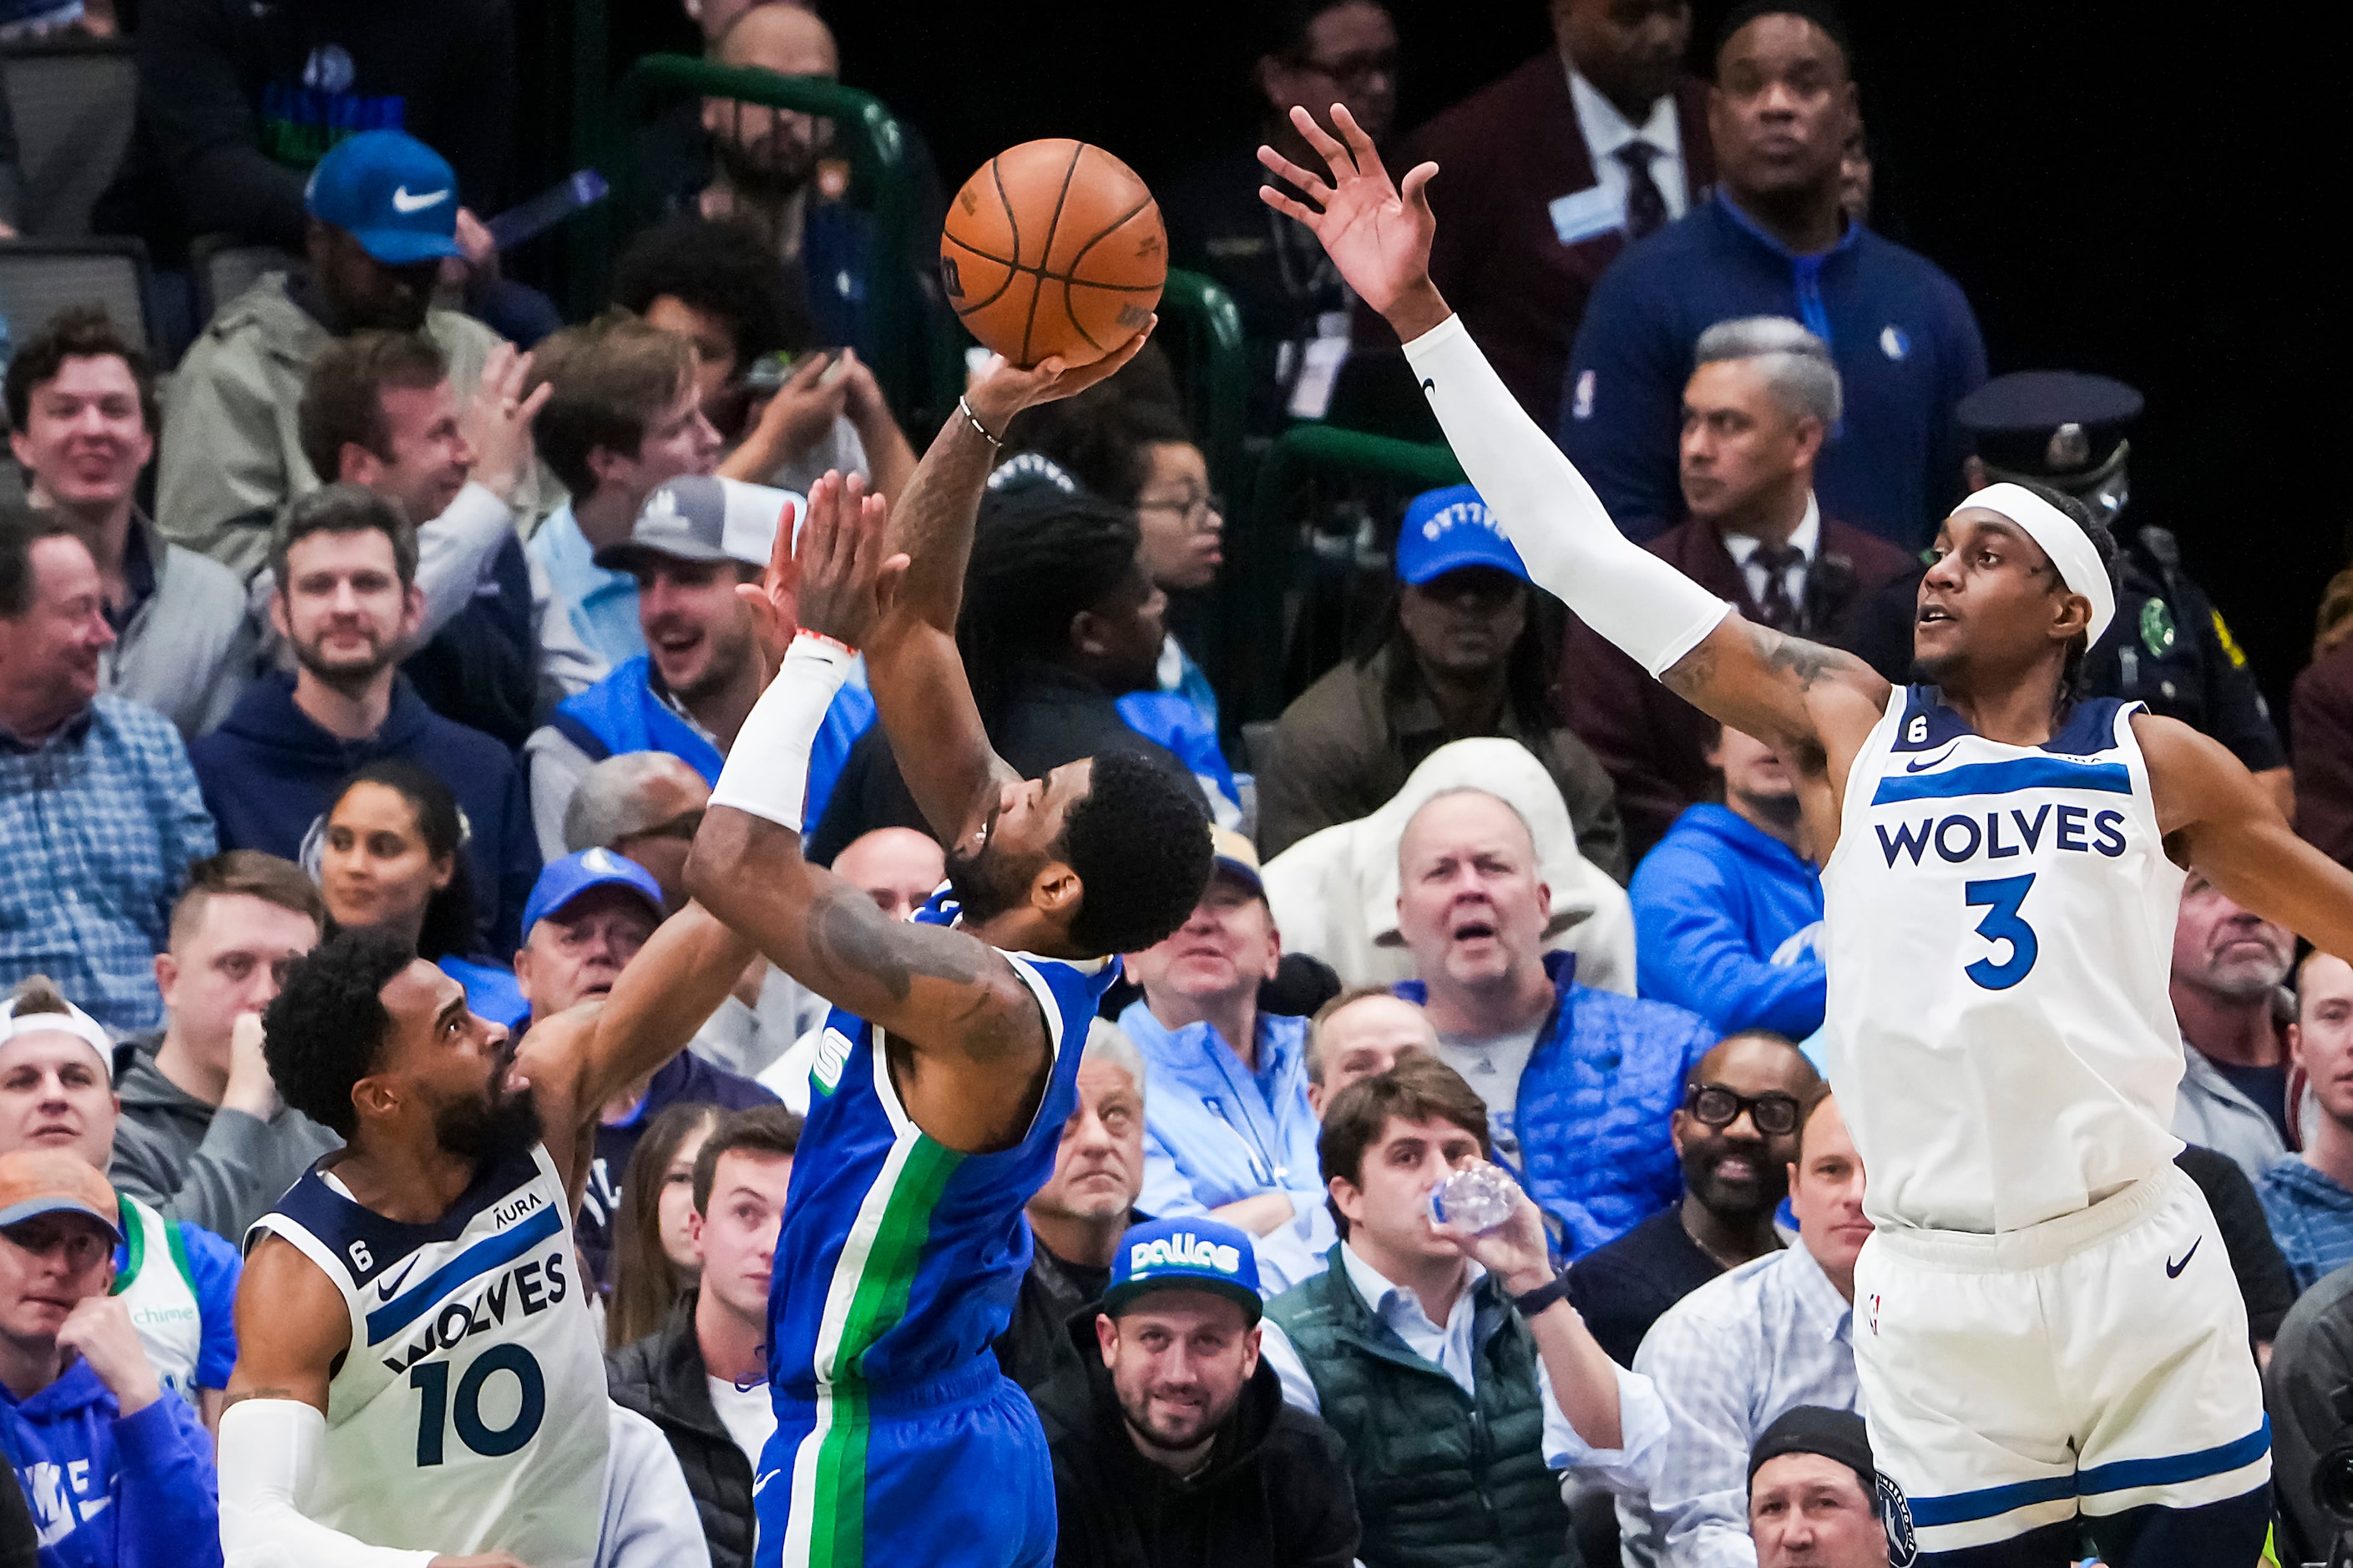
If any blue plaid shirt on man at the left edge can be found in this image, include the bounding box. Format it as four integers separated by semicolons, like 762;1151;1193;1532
0;697;214;1029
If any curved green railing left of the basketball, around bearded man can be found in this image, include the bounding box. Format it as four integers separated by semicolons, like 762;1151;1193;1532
602;54;934;419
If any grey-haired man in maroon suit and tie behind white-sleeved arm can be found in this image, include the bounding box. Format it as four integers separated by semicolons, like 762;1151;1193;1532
1560;316;1913;859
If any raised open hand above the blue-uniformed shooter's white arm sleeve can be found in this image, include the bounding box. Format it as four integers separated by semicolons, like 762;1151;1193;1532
736;471;906;675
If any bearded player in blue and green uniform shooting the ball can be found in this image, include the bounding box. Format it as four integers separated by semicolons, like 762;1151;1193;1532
687;346;1209;1568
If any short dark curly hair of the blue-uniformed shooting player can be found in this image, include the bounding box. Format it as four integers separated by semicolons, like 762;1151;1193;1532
1061;751;1209;956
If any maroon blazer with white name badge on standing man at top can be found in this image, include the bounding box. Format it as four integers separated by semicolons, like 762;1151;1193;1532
1390;49;1715;431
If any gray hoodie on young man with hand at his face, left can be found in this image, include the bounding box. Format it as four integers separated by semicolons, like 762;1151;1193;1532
109;1031;343;1246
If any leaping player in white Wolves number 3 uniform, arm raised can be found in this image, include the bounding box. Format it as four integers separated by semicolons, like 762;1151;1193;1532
1259;106;2353;1568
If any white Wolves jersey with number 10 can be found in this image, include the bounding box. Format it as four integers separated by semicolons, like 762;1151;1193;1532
245;1144;607;1568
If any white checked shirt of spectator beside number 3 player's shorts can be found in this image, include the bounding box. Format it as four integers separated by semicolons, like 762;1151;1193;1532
1619;1241;1856;1568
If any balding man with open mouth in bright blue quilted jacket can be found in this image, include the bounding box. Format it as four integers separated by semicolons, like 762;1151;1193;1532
1398;789;1718;1257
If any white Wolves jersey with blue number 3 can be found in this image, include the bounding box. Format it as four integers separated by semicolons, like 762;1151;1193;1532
1821;685;2183;1232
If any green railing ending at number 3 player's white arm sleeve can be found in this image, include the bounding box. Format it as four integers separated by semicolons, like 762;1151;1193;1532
1222;424;1464;723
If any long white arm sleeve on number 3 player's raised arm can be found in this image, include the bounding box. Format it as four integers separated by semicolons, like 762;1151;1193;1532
1404;316;1732;675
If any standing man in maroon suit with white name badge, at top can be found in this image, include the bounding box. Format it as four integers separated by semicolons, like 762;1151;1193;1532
1393;0;1715;428
